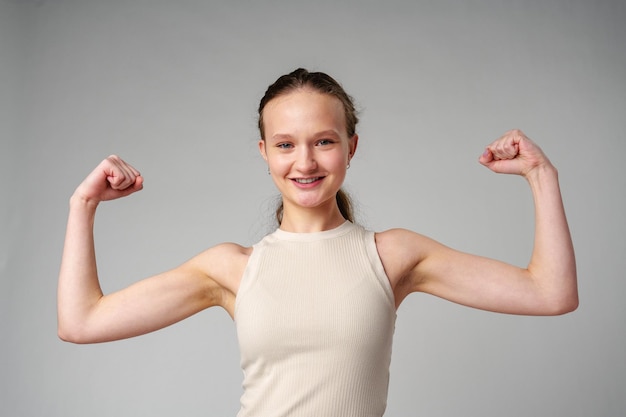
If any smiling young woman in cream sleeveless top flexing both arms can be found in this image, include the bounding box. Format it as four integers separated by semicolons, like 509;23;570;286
58;69;578;417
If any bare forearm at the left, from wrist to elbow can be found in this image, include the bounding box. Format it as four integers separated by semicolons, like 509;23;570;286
57;197;102;340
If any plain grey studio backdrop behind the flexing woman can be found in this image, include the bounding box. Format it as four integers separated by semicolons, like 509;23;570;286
0;0;626;417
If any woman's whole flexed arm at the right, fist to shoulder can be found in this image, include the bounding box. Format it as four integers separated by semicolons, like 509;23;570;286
377;130;578;315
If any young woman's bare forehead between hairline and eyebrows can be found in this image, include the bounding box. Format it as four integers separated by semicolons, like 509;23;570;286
263;89;346;135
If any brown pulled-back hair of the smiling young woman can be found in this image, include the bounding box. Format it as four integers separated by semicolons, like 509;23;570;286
258;68;359;224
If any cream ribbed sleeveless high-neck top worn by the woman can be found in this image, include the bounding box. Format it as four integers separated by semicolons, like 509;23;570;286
235;222;396;417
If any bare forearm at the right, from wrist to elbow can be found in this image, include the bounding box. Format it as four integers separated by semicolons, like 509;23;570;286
526;163;578;314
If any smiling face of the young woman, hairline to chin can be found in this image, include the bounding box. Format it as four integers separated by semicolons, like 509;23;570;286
259;89;358;216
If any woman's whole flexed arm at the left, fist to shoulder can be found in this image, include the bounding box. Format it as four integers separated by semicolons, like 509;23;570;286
58;156;238;343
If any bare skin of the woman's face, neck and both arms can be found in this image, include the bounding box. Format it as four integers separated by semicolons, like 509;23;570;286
58;89;578;343
